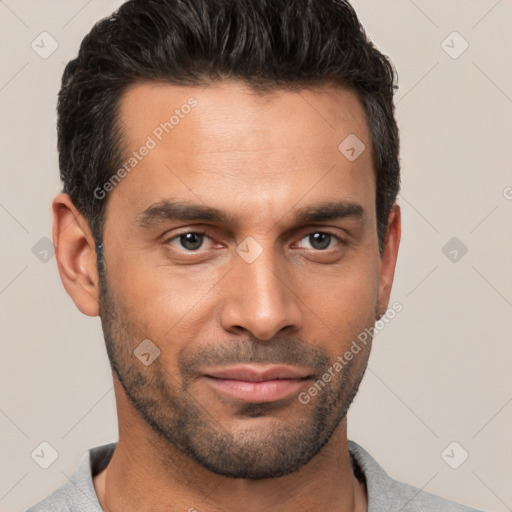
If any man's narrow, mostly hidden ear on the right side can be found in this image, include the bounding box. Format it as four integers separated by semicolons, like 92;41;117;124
378;204;402;318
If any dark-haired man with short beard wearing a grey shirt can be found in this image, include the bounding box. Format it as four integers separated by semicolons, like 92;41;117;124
30;0;482;512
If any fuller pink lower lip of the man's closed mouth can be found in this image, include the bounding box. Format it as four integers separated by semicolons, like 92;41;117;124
206;376;305;402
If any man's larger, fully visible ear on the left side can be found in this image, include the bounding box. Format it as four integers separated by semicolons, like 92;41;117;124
52;194;99;316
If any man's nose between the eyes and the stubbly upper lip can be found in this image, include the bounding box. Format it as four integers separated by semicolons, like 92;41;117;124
220;249;303;341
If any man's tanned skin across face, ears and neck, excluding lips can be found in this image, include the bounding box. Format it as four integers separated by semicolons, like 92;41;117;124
53;81;400;512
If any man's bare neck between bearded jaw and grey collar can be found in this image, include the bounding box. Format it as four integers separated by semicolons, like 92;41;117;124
94;384;366;512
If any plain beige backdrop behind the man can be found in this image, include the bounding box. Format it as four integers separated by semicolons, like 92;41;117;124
0;0;512;511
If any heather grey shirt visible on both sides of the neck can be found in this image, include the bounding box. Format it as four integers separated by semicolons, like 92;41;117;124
27;441;478;512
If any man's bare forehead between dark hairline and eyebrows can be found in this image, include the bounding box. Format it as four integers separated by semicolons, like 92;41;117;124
112;81;375;221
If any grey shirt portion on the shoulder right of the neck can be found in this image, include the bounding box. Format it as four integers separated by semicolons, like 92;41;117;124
348;441;479;512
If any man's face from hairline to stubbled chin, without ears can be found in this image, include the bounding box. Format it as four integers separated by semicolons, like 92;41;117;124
101;82;387;478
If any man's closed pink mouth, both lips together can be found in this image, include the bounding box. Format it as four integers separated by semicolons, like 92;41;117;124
203;365;312;403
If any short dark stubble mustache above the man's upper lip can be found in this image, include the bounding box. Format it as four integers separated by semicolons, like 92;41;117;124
179;338;330;382
